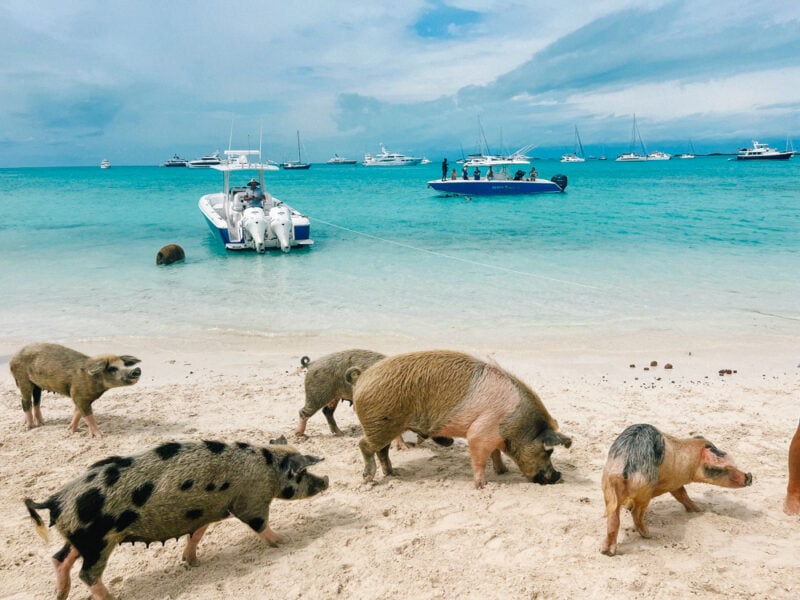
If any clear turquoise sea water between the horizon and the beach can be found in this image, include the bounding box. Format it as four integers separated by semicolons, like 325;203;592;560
0;157;800;345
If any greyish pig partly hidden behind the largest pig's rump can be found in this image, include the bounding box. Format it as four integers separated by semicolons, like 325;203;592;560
295;349;385;436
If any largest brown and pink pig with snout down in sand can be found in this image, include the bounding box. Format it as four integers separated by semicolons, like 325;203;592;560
353;350;572;488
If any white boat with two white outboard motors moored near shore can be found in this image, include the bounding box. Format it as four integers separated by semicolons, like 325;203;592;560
198;150;314;253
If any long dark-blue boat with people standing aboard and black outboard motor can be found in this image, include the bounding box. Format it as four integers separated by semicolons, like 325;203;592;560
428;167;567;196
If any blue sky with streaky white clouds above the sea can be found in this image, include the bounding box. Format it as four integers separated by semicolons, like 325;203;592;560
0;0;800;167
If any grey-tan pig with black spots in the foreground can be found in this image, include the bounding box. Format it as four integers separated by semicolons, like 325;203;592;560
25;441;328;600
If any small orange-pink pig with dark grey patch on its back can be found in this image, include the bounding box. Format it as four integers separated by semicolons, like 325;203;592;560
601;424;753;556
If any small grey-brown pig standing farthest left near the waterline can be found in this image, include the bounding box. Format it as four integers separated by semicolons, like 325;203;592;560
9;344;142;437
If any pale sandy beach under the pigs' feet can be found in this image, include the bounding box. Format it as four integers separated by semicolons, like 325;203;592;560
0;337;800;600
